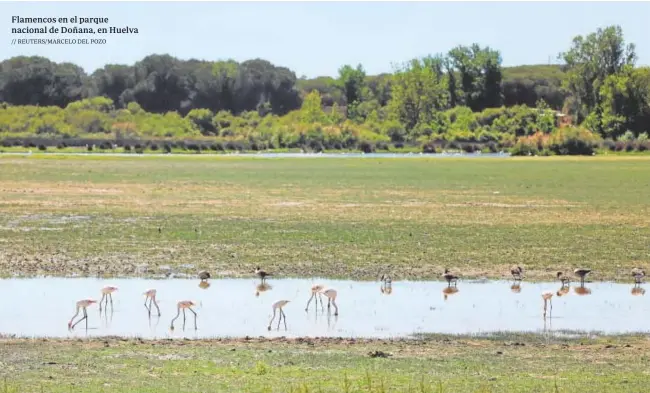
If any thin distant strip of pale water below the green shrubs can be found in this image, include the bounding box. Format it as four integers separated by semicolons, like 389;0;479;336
0;152;510;158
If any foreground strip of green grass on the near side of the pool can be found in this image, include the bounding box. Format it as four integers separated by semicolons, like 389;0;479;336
0;335;650;393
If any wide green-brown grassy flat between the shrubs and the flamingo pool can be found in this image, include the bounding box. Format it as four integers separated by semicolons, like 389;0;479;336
0;154;650;281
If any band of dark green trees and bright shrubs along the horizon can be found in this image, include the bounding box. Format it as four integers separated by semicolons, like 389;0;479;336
0;26;650;154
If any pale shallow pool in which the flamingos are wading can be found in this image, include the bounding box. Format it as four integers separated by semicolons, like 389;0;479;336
0;278;650;338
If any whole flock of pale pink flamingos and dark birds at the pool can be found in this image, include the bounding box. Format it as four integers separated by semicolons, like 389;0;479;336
68;266;645;330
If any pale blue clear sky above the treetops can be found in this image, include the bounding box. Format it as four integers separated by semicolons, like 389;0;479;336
0;1;650;78
